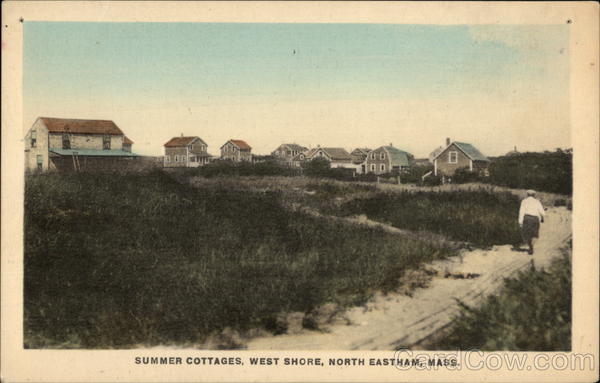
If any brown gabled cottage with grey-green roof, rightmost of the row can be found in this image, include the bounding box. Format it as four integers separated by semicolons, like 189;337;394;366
433;138;490;176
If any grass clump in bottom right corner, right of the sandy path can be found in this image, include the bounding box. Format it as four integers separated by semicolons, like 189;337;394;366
428;251;571;351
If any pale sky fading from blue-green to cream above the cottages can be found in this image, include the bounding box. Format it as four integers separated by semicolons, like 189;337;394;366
23;22;570;157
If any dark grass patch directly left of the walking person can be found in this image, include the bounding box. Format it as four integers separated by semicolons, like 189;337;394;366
339;190;520;247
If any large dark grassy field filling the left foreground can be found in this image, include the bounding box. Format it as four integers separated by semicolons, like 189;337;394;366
24;171;454;348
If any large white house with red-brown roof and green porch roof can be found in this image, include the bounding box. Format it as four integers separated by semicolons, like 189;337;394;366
25;117;138;171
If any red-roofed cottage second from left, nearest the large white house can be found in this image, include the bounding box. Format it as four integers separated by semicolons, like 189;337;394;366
163;134;212;168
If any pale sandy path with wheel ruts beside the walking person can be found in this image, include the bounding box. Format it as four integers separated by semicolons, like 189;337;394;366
247;207;571;350
